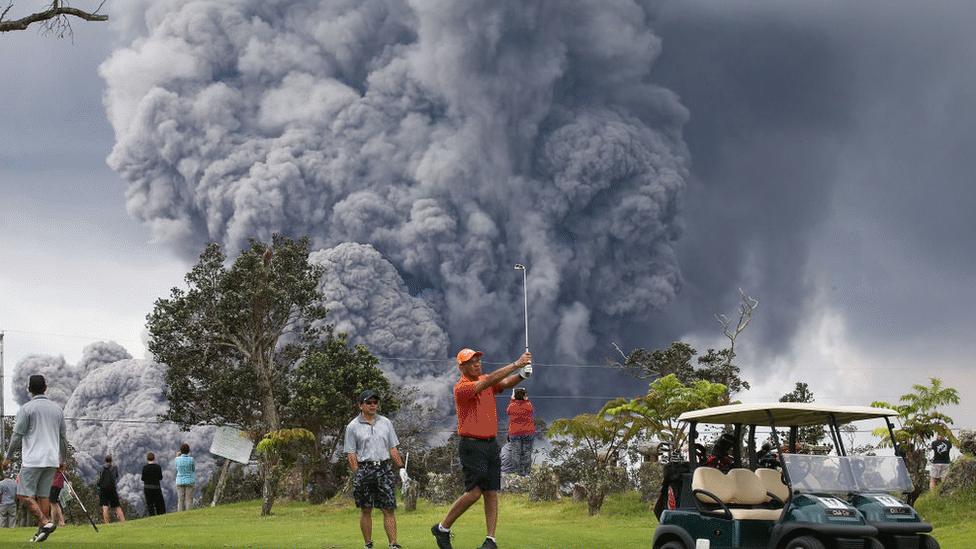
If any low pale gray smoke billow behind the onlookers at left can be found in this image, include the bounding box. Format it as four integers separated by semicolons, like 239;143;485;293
64;359;214;509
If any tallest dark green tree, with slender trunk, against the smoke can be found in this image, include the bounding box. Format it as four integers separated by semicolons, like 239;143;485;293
147;235;325;515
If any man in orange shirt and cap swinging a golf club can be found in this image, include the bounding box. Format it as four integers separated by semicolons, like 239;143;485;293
430;349;532;549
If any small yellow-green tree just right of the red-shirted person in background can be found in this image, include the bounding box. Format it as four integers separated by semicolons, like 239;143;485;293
549;406;636;515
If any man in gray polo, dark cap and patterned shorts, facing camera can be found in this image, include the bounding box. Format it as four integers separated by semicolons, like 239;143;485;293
342;389;404;549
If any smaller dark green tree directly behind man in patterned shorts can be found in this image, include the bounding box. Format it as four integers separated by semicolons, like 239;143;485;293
284;326;401;501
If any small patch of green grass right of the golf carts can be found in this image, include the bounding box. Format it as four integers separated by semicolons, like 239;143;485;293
915;490;976;549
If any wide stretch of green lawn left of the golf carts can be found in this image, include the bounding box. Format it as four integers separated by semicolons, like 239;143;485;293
0;493;657;549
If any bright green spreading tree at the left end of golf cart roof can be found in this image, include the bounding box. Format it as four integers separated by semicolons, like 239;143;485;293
604;374;728;458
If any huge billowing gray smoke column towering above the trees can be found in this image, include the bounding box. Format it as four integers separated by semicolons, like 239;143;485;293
101;0;687;364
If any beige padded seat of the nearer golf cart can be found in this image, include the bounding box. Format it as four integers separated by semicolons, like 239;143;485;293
691;467;783;520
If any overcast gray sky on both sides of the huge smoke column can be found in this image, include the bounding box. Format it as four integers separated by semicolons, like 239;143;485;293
0;1;976;428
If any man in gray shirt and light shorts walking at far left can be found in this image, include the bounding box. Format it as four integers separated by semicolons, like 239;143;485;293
3;375;68;541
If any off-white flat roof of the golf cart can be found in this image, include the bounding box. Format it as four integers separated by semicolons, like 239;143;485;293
678;402;898;427
